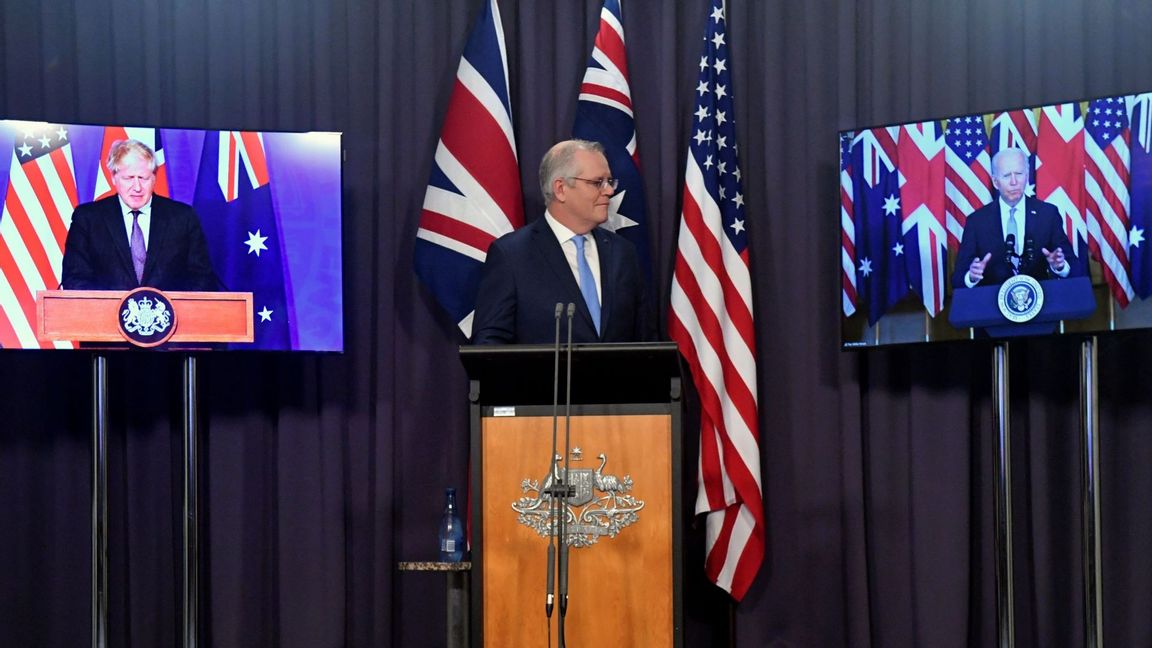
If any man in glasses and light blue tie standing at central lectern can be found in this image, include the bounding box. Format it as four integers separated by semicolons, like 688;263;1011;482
472;140;654;345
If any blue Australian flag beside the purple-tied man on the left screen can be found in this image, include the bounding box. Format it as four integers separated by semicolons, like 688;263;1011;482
192;130;295;349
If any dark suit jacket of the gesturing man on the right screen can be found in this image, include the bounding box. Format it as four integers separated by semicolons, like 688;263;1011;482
952;197;1083;288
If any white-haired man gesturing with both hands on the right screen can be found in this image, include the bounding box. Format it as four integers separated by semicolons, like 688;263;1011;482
952;149;1082;288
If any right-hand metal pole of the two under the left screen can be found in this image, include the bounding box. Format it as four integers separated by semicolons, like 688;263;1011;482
183;354;200;648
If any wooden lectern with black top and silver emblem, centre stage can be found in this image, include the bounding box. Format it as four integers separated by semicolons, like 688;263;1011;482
460;342;683;648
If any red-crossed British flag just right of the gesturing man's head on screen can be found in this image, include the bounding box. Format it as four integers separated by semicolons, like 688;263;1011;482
1034;104;1087;261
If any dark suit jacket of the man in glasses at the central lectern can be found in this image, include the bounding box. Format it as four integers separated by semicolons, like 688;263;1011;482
472;217;655;345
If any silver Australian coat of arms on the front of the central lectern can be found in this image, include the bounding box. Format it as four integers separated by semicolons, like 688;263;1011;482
511;449;644;548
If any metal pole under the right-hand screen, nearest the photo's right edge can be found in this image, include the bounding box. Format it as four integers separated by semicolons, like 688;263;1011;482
1081;336;1104;648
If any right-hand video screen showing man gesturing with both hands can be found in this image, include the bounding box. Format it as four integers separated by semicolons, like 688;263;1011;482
840;92;1152;348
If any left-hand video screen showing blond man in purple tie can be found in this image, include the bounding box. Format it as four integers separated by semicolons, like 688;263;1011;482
0;120;343;352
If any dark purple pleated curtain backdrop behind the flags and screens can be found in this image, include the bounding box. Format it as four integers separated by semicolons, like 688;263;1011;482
0;0;1152;648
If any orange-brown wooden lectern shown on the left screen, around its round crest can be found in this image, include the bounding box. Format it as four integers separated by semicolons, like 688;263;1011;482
36;291;255;342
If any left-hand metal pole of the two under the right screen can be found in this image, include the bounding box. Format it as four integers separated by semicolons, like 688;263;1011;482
992;341;1016;648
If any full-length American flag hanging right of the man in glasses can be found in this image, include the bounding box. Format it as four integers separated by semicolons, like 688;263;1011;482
668;0;764;601
